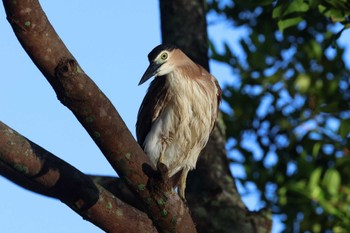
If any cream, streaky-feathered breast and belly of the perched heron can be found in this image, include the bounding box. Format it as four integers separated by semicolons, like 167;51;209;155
144;70;217;176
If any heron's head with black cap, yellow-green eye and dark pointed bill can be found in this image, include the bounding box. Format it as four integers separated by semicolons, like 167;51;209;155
139;44;177;85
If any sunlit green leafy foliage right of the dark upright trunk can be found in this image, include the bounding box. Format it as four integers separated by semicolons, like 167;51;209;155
209;0;350;232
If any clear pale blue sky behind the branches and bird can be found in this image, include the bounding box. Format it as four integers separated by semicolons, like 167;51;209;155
0;0;350;233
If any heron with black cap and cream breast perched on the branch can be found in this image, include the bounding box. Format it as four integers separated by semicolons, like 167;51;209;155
136;44;221;199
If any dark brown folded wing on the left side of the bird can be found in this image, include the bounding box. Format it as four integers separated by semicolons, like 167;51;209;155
136;77;167;148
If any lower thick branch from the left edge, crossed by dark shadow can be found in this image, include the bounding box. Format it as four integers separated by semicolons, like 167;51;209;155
0;122;156;233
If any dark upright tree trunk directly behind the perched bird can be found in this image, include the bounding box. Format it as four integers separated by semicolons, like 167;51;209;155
160;0;271;233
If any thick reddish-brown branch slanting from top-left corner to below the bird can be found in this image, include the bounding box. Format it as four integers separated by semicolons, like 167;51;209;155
3;0;196;232
